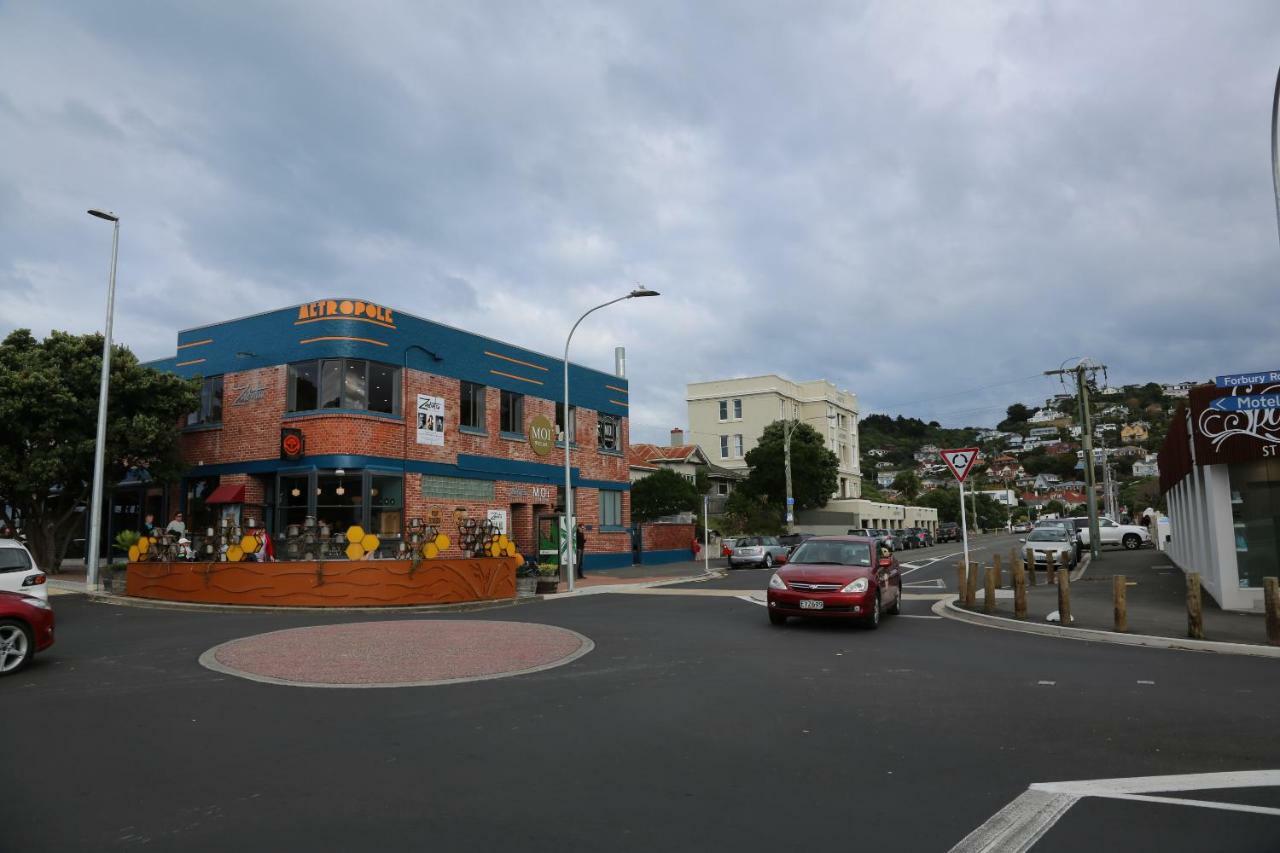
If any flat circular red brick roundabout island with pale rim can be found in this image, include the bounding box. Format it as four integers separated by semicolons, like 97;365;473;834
200;620;594;688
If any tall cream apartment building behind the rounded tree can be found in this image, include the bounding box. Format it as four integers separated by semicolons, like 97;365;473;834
685;374;863;500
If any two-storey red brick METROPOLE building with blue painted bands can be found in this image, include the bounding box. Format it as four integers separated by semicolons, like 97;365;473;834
151;300;632;570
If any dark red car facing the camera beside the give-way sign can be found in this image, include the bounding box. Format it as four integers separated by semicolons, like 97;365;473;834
769;537;902;628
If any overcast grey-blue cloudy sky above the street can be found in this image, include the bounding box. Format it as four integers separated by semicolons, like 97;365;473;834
0;0;1280;439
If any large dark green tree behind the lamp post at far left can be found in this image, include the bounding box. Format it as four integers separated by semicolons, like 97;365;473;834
0;329;200;571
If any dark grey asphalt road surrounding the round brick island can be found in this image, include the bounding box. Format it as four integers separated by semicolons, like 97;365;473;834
0;578;1280;853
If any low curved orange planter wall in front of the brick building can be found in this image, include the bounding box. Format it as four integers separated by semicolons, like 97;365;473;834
125;558;516;607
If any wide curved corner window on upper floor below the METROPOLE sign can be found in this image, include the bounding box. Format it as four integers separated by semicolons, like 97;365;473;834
288;359;401;415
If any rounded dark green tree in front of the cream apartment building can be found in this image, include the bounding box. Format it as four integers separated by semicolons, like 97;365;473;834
746;420;840;512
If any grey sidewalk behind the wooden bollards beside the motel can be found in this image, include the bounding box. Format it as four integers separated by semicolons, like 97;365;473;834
974;548;1267;646
